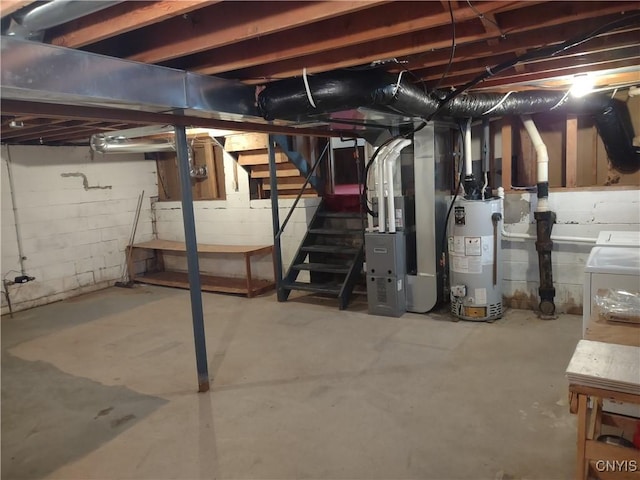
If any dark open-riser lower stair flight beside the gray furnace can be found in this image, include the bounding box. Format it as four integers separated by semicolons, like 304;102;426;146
282;200;364;310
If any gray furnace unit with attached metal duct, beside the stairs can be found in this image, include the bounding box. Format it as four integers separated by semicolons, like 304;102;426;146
365;122;456;316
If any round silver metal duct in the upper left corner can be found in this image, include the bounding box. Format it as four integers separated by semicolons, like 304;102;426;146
5;0;120;40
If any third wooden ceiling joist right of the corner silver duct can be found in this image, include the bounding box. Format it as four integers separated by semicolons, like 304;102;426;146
180;1;518;75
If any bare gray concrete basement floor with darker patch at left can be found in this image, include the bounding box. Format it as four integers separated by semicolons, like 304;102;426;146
2;286;580;480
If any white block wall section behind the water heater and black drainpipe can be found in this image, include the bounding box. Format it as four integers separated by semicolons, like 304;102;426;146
502;188;640;314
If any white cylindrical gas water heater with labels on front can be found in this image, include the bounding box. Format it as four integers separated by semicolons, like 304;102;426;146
448;198;503;321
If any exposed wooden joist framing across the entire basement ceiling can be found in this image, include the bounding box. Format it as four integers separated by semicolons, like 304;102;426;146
0;0;640;144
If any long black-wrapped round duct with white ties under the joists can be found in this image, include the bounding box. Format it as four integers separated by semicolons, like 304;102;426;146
258;70;640;173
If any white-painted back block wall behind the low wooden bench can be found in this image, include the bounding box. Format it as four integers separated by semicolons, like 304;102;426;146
154;148;320;279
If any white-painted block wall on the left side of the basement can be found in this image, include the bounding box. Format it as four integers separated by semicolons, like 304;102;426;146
1;145;157;313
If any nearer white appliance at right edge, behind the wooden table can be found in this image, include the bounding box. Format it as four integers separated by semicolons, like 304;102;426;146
582;245;640;337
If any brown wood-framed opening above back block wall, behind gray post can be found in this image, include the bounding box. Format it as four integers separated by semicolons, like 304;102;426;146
155;137;226;201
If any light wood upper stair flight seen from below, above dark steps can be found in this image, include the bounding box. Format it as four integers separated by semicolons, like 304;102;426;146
224;133;321;198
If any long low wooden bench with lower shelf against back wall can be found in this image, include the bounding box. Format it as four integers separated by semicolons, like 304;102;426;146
127;240;275;297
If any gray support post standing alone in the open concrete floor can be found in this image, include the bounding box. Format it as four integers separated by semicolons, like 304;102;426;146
174;125;209;392
